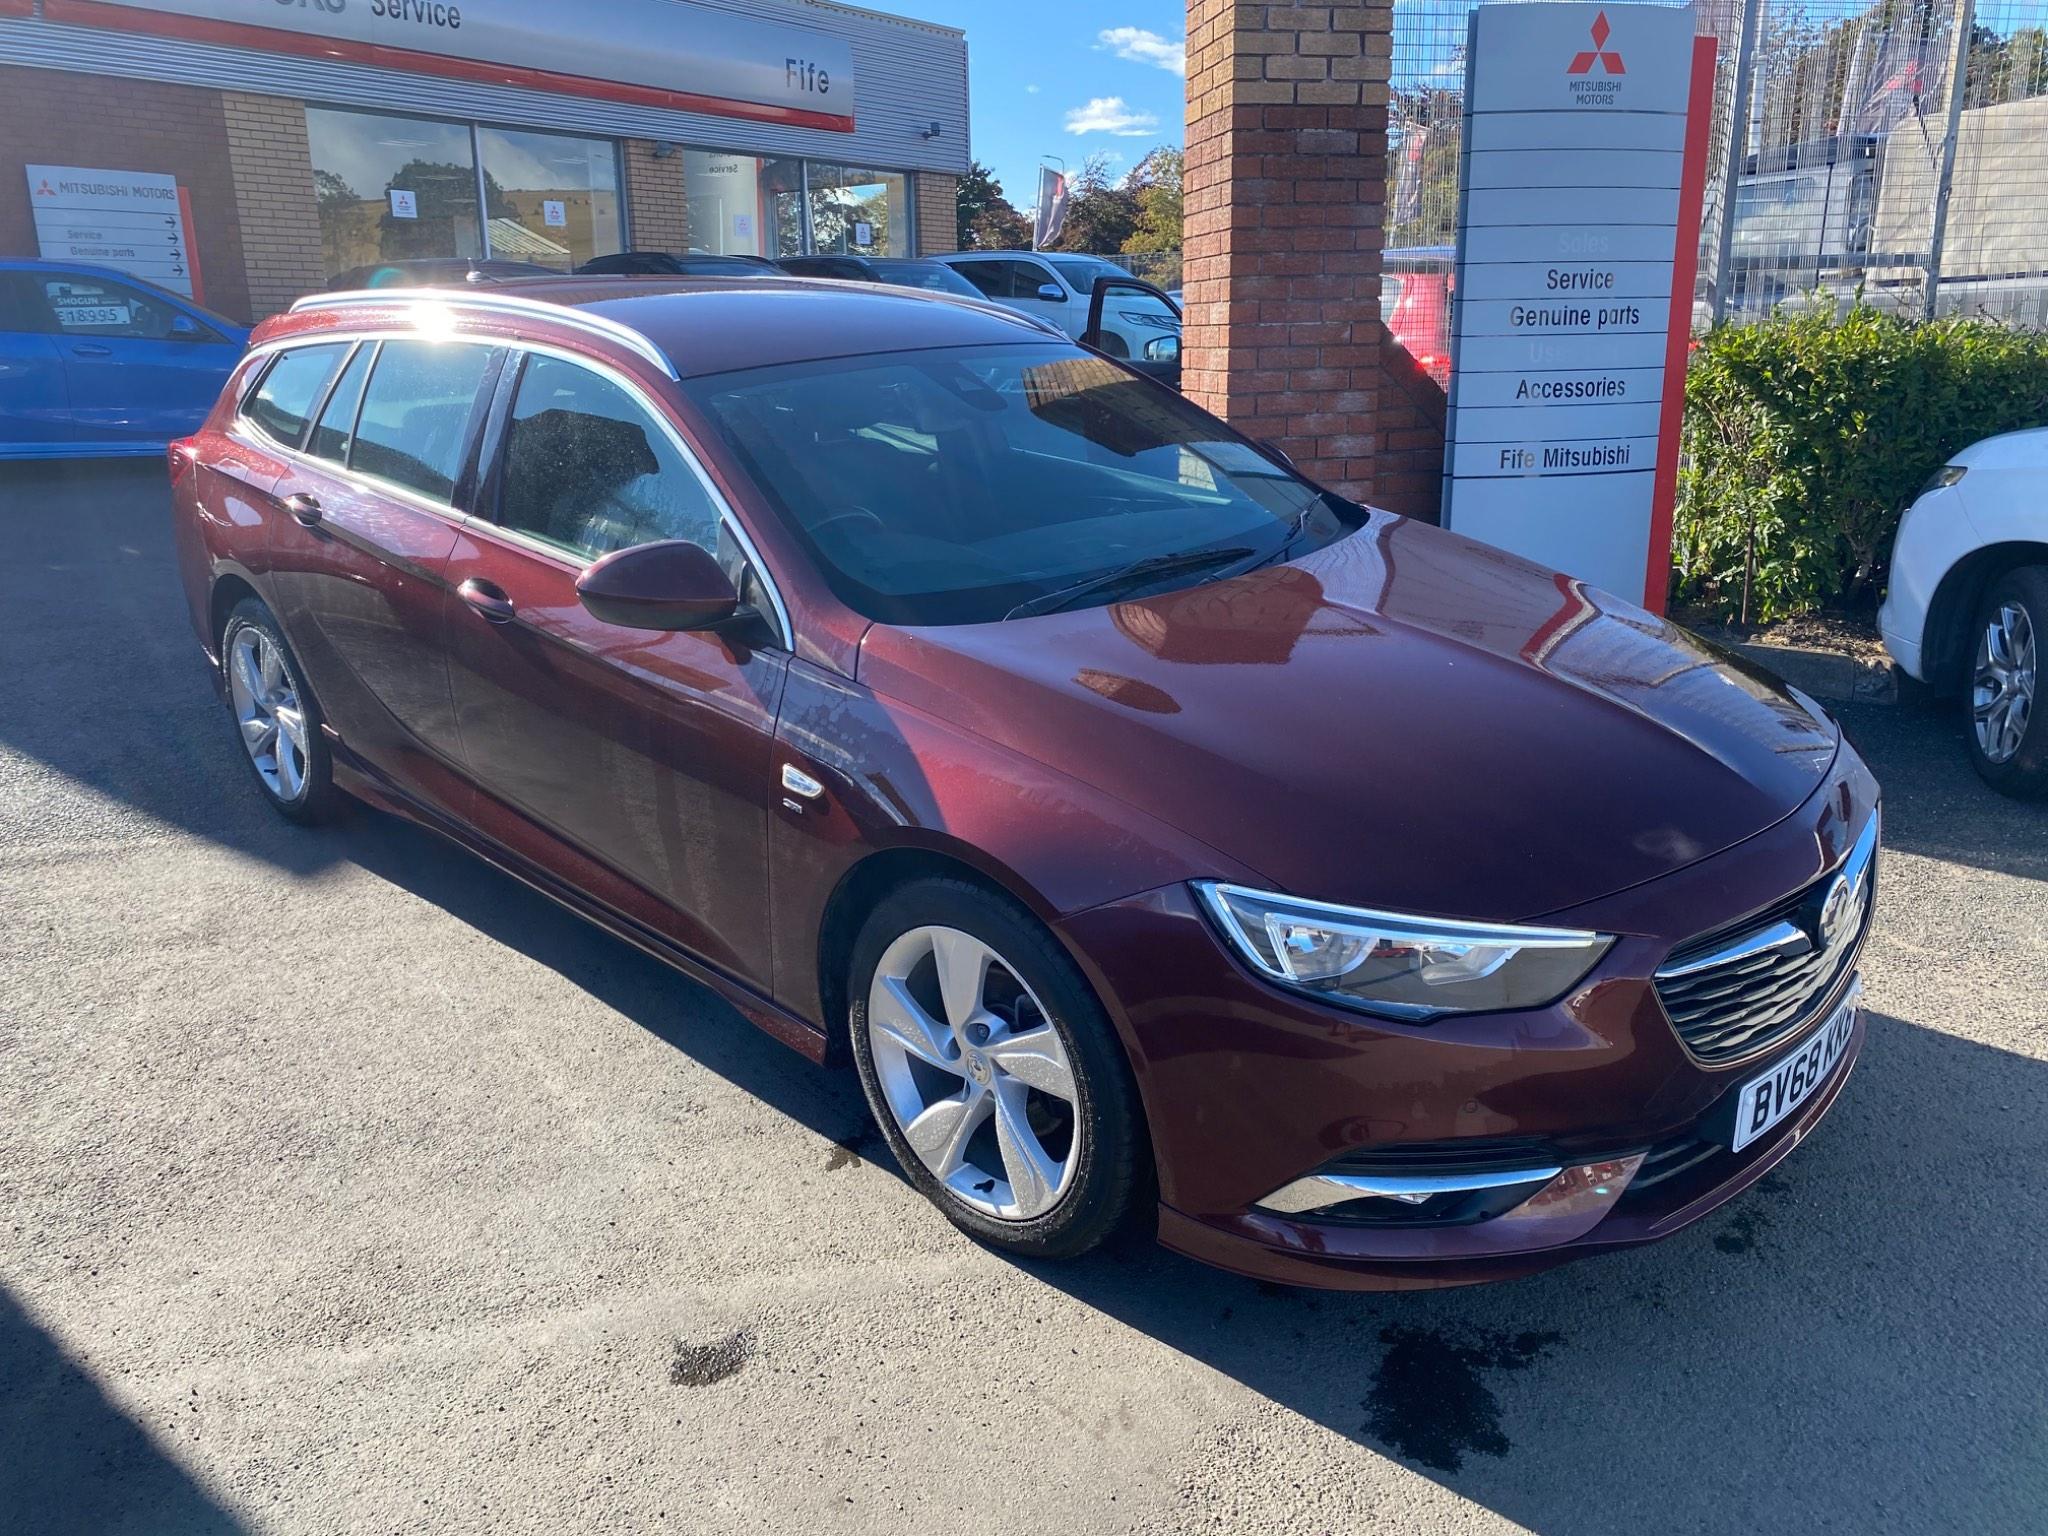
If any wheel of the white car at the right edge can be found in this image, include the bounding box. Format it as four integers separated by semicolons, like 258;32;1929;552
1964;565;2048;799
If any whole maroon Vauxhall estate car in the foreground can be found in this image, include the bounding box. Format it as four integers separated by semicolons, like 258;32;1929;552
170;279;1878;1288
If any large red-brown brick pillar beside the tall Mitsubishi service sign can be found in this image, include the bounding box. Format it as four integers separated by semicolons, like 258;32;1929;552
1182;0;1442;516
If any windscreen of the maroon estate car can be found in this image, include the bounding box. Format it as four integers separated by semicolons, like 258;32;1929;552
684;344;1362;625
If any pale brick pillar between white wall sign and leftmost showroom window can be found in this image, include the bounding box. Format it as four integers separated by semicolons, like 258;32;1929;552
221;90;328;319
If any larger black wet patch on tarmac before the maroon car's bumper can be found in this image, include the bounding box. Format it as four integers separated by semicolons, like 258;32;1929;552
1360;1327;1563;1473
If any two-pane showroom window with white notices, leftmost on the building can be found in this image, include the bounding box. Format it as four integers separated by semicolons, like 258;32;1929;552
305;106;625;283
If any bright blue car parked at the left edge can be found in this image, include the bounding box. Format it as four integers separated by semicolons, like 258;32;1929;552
0;260;250;459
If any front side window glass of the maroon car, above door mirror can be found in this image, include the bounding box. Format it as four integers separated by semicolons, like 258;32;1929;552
498;356;719;559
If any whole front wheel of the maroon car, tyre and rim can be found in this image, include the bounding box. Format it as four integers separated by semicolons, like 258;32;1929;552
848;879;1149;1257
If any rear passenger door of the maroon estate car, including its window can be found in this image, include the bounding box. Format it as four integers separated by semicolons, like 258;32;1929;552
252;336;491;813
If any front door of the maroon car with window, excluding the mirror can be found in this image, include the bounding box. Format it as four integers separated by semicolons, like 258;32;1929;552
449;350;788;991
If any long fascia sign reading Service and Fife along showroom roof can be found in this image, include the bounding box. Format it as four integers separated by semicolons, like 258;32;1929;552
43;0;854;133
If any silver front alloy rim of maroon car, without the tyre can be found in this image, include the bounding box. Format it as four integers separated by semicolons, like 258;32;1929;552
866;926;1081;1221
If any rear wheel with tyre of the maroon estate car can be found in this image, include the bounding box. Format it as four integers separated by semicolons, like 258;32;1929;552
221;598;344;821
